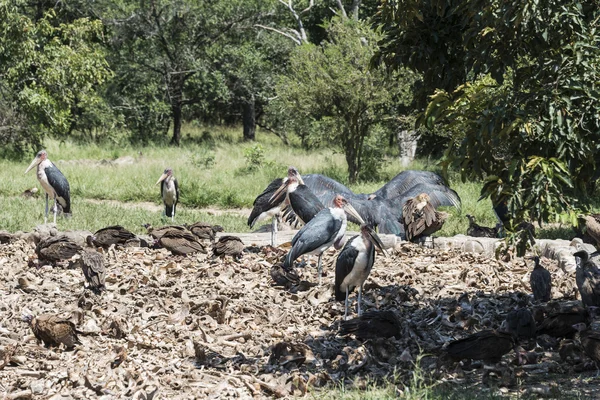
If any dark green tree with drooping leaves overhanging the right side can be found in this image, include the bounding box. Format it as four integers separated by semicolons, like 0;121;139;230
378;0;600;234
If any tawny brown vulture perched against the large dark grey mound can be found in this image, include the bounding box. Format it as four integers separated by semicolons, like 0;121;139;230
402;193;448;242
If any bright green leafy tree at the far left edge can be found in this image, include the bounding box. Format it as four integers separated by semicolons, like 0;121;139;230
0;2;111;155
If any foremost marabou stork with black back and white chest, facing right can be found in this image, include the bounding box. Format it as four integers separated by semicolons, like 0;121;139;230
335;224;386;320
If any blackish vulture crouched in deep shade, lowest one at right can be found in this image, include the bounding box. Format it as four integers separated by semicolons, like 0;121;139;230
446;330;515;362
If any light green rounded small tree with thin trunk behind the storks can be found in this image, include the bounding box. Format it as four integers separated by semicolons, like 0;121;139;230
271;18;408;182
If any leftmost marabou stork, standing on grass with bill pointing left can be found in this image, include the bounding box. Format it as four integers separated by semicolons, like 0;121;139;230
25;150;71;224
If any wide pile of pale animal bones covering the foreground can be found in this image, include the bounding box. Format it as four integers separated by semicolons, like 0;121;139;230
0;234;595;399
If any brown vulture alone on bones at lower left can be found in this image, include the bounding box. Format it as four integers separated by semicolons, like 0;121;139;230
23;314;81;348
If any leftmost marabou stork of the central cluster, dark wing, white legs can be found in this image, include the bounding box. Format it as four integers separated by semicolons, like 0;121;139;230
248;167;302;246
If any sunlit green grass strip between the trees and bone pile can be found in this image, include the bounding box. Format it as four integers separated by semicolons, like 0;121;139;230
0;127;516;235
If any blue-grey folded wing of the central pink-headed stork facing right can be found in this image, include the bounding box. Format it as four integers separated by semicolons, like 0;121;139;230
284;208;342;267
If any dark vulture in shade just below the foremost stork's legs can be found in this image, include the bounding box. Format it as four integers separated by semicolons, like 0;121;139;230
340;310;402;339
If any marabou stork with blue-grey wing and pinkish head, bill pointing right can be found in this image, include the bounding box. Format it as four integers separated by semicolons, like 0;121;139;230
283;195;364;283
